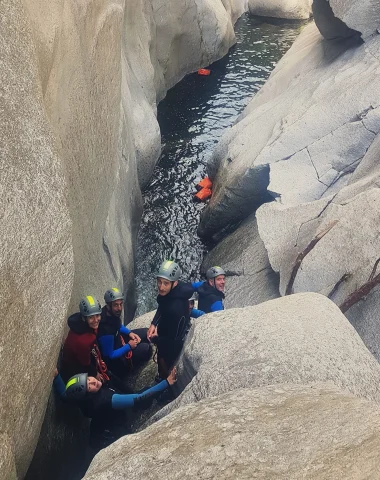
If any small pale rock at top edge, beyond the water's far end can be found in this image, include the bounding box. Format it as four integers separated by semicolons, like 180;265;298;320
248;0;312;20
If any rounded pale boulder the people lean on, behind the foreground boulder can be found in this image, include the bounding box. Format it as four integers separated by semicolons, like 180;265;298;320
155;293;380;418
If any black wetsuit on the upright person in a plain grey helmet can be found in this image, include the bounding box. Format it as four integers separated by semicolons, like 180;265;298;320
152;281;194;369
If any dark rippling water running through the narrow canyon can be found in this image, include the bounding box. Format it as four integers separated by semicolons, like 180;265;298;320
137;15;303;315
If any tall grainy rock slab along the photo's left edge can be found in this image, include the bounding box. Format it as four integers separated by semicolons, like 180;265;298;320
0;0;74;479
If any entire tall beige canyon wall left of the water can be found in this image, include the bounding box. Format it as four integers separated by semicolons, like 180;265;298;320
0;0;246;478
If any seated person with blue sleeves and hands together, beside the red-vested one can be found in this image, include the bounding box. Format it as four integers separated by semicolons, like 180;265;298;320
98;288;152;378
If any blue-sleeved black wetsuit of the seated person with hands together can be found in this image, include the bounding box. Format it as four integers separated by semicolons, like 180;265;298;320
97;307;151;377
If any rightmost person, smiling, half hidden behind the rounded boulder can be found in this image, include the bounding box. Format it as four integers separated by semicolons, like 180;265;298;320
193;266;226;313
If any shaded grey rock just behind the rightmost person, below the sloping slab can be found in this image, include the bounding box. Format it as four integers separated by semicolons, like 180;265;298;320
202;215;279;308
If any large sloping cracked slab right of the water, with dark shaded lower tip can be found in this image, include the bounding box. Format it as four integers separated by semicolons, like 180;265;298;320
199;24;380;243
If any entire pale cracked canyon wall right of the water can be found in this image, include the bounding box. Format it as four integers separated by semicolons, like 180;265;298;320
199;0;380;359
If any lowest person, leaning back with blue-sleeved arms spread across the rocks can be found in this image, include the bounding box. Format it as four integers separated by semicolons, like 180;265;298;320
53;369;177;448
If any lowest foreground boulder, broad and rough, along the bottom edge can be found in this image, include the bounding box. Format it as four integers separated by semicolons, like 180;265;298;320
84;383;380;480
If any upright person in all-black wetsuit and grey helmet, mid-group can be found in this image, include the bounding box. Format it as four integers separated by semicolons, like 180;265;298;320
148;260;194;380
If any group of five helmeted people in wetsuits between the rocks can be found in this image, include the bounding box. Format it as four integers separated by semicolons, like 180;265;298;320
54;260;225;446
